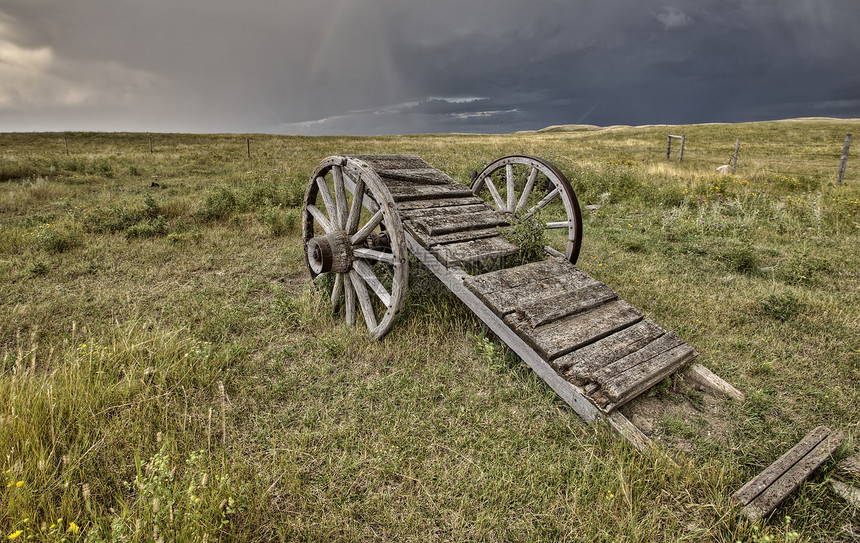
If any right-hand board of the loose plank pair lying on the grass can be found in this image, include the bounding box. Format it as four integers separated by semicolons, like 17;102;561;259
733;428;844;522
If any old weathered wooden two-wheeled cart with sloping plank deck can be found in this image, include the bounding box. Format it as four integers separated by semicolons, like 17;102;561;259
303;155;739;449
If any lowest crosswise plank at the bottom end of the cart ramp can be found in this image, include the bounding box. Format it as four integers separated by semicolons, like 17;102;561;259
592;343;696;411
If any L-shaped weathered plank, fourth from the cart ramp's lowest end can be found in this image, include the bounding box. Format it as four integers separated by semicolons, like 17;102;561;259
505;300;642;360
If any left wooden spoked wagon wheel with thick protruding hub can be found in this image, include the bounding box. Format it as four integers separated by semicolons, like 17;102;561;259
302;156;409;339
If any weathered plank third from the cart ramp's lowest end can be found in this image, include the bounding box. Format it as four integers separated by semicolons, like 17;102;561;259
554;319;666;385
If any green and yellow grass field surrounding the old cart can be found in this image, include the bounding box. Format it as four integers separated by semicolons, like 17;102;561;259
0;120;860;542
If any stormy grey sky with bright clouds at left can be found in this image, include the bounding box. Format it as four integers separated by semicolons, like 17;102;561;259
0;0;860;135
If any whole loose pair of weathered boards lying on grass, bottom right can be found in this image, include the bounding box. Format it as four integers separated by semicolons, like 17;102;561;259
732;426;843;521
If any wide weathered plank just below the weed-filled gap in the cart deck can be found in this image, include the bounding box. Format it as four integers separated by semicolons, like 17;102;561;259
465;257;596;316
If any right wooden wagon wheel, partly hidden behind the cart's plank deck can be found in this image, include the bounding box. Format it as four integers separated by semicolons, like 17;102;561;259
472;155;582;264
